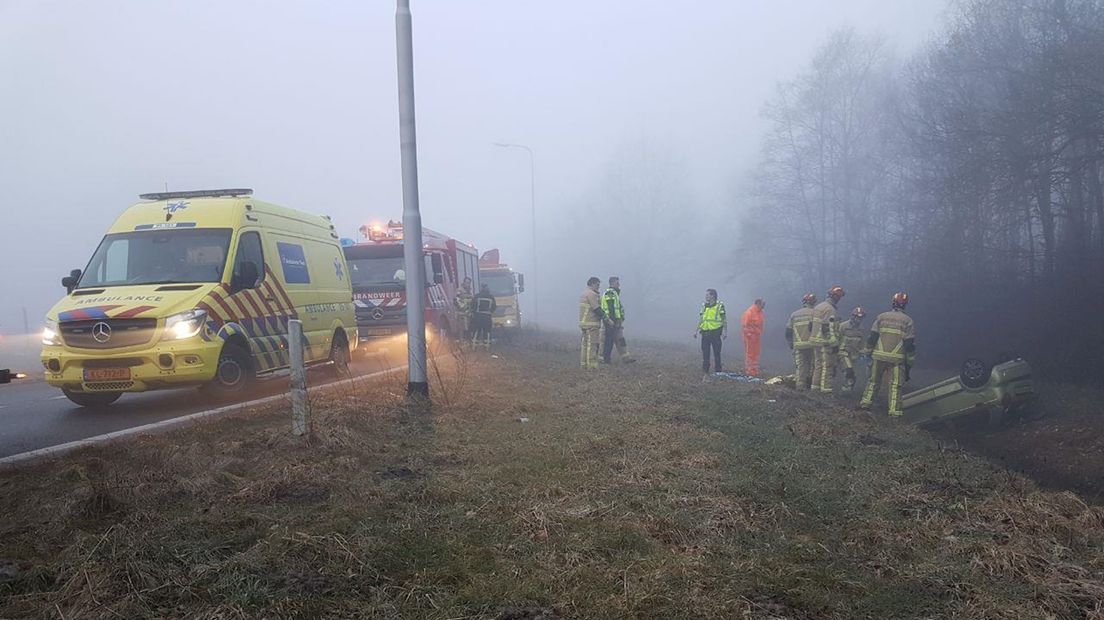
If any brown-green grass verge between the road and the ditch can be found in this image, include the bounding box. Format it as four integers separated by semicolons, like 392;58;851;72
0;330;1104;619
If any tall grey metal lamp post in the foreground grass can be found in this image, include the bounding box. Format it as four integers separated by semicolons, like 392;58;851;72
395;0;429;398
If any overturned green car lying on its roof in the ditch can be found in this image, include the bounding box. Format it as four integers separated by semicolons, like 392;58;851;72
901;359;1034;426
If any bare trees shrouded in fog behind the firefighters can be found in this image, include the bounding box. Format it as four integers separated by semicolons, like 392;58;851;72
737;0;1104;380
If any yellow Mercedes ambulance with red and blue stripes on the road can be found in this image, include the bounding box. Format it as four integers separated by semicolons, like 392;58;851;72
42;190;357;407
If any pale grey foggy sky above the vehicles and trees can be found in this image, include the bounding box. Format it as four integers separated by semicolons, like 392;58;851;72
0;0;944;337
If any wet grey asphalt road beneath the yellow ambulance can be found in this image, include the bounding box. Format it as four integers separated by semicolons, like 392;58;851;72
0;352;406;457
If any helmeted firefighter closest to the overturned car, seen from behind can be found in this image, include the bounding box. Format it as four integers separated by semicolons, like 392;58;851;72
859;292;916;416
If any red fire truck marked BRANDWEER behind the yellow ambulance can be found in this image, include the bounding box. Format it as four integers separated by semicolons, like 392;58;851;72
344;222;479;342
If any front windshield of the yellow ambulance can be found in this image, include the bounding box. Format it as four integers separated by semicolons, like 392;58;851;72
78;228;231;288
